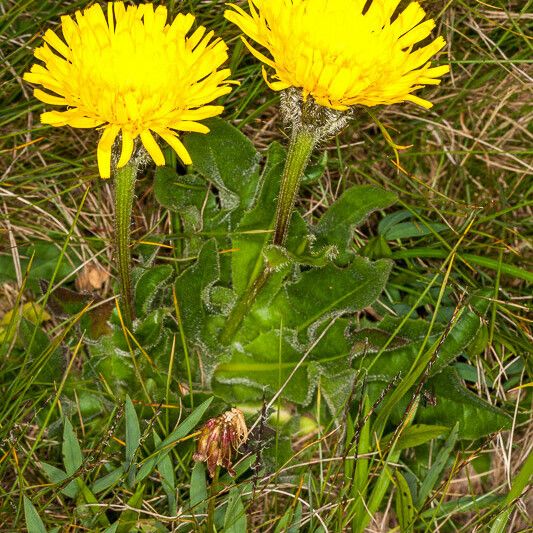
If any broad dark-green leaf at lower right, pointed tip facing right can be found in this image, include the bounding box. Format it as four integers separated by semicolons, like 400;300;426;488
416;368;511;440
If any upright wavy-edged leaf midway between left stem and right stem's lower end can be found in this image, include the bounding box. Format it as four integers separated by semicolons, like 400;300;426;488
175;239;220;339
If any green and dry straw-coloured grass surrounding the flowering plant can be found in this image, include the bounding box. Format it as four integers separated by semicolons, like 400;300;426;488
0;0;533;532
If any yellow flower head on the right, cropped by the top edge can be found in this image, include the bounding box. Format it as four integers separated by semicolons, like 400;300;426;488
225;0;449;111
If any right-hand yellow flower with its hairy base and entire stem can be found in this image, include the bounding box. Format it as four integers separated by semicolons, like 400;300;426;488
222;0;449;341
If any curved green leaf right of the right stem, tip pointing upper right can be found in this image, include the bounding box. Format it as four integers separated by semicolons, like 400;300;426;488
315;185;396;255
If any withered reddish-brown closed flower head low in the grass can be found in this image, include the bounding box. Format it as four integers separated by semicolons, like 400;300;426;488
193;408;248;477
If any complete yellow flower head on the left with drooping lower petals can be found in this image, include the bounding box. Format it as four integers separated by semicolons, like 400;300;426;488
24;2;231;178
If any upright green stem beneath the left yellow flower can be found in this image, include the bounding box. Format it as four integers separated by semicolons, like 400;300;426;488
115;163;137;327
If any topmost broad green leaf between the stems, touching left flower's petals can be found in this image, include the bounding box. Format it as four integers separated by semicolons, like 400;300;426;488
183;118;259;215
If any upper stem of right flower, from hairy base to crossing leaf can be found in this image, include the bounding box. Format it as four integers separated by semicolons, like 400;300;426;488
272;127;317;246
